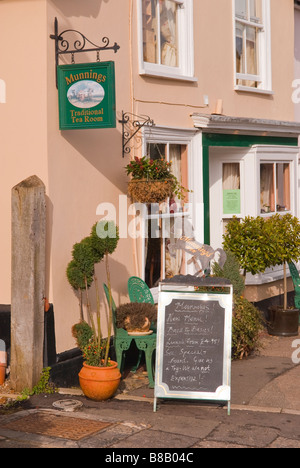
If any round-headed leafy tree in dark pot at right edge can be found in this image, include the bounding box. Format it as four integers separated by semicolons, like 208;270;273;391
223;214;300;336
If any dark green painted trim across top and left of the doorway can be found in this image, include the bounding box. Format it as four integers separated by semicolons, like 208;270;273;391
202;133;298;241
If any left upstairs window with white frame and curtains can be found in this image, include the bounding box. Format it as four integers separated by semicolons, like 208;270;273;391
139;0;193;79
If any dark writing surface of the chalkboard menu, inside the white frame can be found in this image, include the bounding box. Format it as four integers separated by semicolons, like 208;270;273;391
163;299;225;392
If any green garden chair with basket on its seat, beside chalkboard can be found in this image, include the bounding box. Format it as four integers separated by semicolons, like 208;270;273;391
103;284;156;388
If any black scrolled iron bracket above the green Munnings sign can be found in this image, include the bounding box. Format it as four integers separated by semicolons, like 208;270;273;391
50;18;120;87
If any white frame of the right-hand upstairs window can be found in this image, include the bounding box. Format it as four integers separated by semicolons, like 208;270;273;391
232;0;274;94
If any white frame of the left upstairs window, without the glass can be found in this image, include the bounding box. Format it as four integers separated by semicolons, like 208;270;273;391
137;0;197;81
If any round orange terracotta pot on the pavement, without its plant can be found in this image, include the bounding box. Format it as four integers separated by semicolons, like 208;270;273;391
79;361;121;401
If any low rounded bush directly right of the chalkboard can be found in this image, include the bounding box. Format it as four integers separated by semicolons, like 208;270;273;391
232;295;263;359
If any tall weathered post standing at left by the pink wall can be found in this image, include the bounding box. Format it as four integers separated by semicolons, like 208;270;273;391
11;176;46;391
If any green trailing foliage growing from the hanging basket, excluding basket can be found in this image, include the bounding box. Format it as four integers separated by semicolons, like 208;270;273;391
125;156;189;200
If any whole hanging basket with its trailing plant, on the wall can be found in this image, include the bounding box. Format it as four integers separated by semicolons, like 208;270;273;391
125;156;188;203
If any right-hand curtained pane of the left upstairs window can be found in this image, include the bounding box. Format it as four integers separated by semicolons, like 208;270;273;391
160;0;178;67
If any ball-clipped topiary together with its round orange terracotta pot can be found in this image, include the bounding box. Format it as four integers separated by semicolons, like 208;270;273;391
67;221;121;401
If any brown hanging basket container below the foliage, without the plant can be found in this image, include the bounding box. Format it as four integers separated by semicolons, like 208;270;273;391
128;179;174;203
